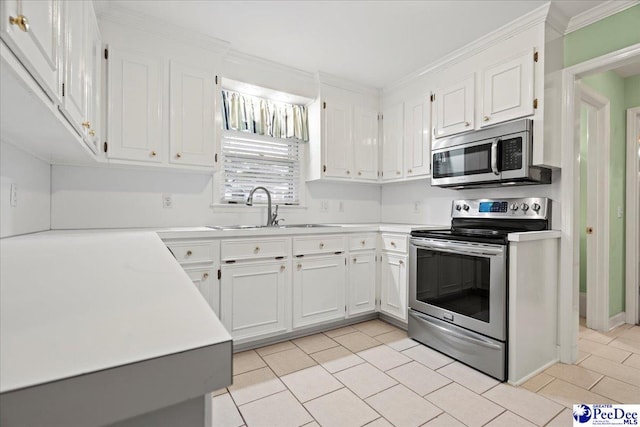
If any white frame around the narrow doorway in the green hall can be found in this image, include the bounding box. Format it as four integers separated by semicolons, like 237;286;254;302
576;82;611;332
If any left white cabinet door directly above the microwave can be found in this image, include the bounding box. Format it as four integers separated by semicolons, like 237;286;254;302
435;75;475;138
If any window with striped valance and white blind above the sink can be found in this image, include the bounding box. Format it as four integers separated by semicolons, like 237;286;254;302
222;90;309;205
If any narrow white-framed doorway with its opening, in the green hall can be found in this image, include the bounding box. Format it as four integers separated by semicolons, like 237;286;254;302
576;83;611;332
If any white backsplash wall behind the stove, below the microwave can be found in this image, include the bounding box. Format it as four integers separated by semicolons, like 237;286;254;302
380;171;562;229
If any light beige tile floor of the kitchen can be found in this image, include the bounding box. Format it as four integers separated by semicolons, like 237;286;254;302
212;320;640;427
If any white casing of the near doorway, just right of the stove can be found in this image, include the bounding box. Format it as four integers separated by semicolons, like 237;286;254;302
558;43;640;364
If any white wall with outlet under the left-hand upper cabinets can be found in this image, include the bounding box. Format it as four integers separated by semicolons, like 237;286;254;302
0;142;51;237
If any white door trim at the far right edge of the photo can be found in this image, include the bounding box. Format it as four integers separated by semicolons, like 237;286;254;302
625;107;640;325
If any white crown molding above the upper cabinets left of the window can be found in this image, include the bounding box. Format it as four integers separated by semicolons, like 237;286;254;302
97;5;231;55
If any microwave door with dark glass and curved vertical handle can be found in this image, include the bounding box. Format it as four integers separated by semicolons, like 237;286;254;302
431;138;501;186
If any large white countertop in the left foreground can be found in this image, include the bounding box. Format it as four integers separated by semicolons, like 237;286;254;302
0;231;231;393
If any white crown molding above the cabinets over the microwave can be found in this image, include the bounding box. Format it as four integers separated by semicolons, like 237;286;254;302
382;3;550;92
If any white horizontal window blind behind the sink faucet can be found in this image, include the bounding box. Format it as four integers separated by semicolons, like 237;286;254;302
222;131;300;205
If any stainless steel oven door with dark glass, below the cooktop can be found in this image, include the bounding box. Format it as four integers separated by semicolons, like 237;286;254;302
409;238;507;341
